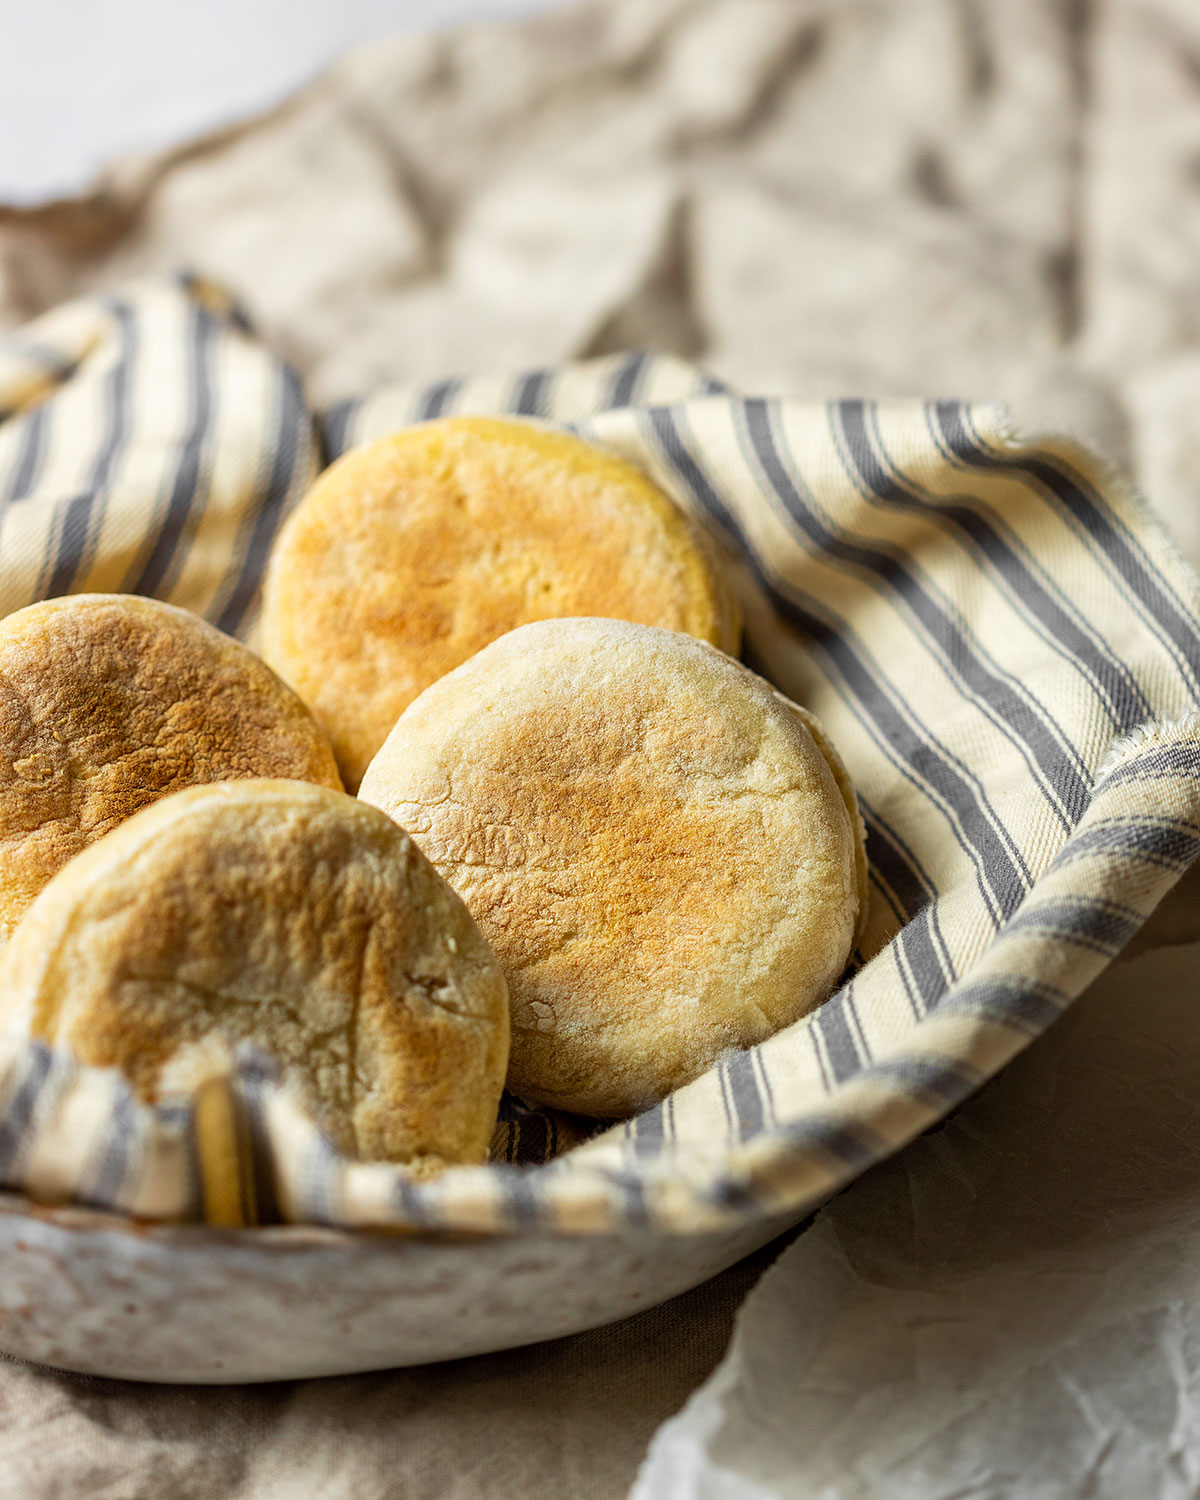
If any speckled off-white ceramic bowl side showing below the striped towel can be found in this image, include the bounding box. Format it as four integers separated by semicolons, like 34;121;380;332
0;1196;786;1385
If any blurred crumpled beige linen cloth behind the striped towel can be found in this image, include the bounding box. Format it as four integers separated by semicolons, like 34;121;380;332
0;0;1200;579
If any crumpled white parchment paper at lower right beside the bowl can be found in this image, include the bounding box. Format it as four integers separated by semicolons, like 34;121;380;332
633;876;1200;1500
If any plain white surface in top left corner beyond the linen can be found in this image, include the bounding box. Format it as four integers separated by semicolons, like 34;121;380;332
0;0;555;204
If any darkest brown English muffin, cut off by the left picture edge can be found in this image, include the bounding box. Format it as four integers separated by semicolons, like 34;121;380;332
0;594;342;945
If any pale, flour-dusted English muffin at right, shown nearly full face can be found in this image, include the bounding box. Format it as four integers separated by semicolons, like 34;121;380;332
360;620;866;1116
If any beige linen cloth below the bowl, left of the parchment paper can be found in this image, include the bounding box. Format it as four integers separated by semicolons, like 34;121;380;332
0;1247;779;1500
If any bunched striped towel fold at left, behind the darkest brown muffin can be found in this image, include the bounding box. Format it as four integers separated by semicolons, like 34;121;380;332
0;273;318;635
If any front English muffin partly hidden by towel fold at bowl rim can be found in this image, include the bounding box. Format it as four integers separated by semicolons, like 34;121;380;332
0;782;509;1173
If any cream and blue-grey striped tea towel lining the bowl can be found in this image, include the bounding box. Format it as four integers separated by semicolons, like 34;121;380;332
0;279;1200;1235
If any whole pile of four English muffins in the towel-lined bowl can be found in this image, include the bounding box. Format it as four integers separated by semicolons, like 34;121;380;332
0;419;866;1176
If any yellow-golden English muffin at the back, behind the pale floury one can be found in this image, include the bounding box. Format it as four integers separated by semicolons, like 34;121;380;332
261;417;741;788
